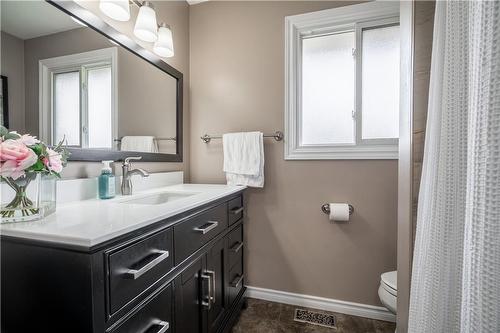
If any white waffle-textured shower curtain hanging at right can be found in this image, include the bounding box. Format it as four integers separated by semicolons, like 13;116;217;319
409;1;500;333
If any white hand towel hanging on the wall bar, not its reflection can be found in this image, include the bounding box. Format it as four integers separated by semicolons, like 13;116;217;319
222;132;264;187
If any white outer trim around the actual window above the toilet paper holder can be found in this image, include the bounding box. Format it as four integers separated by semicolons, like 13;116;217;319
284;1;399;160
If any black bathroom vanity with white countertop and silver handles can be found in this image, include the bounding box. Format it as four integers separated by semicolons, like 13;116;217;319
1;179;245;333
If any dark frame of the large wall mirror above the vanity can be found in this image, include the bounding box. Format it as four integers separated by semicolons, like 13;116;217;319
45;0;183;162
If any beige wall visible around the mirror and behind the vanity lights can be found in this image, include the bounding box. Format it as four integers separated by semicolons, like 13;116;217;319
62;0;190;179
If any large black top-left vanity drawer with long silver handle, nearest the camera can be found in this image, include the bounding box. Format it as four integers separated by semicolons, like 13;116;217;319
109;228;173;313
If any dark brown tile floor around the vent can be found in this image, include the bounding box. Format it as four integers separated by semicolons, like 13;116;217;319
232;298;396;333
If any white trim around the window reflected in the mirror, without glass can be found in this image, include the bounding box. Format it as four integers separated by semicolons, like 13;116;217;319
38;47;118;145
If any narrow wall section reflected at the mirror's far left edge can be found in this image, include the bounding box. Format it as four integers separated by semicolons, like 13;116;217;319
0;32;25;133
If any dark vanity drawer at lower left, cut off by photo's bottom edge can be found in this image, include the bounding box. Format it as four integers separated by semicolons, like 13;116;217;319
112;284;173;333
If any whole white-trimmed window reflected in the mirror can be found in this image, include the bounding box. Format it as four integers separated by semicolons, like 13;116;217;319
40;48;116;148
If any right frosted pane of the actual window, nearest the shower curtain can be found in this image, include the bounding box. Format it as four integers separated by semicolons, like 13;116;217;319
362;26;399;139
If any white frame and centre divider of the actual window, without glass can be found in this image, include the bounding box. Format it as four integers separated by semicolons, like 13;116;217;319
284;1;399;160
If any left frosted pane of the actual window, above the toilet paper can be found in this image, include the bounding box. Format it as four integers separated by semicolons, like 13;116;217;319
301;32;355;144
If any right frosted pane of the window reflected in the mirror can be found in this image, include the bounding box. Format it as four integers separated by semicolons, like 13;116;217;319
87;67;113;148
